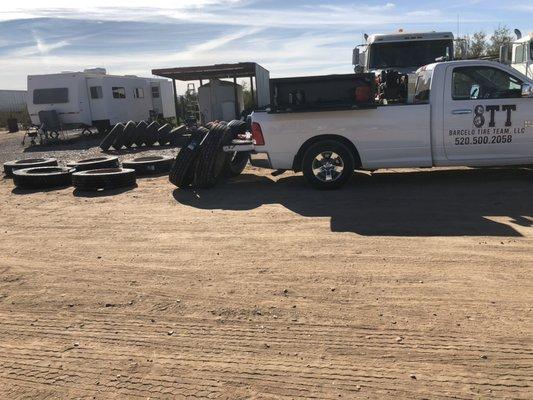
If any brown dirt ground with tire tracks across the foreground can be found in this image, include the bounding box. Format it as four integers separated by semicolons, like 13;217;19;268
0;130;533;399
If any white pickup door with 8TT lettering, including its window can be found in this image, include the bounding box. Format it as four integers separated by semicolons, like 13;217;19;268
443;65;533;165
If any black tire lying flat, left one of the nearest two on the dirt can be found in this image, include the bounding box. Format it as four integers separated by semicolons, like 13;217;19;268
13;167;74;189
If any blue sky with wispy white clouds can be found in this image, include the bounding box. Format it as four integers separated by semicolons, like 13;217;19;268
0;0;533;89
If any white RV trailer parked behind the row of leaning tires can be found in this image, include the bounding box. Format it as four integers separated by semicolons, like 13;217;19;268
27;68;176;130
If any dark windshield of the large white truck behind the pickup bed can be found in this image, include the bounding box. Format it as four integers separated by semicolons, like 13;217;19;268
369;39;453;69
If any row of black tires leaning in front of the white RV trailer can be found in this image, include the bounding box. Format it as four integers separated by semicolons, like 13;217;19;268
100;121;188;151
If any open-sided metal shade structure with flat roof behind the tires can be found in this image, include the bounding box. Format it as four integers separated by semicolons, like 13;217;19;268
152;62;270;117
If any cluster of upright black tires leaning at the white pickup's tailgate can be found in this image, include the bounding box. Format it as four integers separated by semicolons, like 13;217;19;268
169;120;249;188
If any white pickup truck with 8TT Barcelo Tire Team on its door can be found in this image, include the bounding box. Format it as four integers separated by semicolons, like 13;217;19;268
233;60;533;189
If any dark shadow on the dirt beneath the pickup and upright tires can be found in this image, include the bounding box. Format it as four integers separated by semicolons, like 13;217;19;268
174;169;533;236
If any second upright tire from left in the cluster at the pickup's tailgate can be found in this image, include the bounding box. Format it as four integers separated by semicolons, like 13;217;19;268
193;124;233;189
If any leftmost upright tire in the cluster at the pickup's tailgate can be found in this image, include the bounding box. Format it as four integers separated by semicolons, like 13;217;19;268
168;127;210;188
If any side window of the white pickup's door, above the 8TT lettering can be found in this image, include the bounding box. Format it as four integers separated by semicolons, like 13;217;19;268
452;67;522;100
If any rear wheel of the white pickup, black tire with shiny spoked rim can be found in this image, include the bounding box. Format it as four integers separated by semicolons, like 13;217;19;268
302;140;355;190
